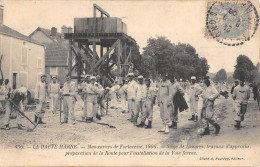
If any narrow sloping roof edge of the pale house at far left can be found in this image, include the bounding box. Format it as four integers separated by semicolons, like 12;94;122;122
0;25;43;46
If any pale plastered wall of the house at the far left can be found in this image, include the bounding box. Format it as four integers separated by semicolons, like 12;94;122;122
0;34;45;92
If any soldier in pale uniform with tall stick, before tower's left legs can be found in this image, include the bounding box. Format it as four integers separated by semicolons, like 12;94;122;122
62;74;76;125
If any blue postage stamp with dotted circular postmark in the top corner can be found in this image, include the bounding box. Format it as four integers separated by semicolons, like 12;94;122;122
206;0;259;46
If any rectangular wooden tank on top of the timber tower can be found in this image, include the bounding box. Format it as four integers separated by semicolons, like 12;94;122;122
74;17;127;34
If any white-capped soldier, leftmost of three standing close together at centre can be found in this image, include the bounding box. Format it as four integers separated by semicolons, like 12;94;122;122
127;73;137;122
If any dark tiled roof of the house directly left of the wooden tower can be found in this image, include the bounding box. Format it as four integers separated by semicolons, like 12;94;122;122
45;43;69;67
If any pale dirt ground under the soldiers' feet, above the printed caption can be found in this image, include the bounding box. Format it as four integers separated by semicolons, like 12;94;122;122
0;94;260;149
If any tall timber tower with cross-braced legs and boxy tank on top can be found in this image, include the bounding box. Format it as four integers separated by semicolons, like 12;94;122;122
65;4;135;84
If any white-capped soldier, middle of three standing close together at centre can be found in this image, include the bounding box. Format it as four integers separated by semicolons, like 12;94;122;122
133;75;146;127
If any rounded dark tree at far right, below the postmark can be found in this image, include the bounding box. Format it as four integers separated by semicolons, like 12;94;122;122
233;55;258;82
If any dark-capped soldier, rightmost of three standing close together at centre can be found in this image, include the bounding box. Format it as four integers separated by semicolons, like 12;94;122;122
144;78;157;129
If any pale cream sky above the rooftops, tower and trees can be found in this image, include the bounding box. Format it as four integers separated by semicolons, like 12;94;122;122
1;0;260;73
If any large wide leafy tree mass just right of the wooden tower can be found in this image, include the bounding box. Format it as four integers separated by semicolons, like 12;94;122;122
140;37;209;80
